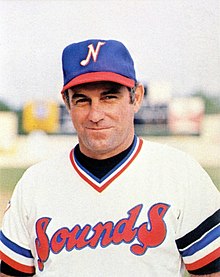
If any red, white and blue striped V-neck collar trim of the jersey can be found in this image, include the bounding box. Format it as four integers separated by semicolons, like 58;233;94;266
70;136;143;192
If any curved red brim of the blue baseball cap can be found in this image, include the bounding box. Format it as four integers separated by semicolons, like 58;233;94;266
61;72;135;93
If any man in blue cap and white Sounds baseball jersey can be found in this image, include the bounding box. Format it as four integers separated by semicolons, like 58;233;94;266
1;40;220;277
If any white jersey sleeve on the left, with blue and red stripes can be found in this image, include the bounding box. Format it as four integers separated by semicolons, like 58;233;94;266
0;170;35;274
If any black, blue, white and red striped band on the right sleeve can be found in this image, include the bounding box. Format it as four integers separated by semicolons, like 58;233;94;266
176;210;220;275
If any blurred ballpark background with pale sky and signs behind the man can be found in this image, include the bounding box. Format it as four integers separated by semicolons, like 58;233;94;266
0;0;220;249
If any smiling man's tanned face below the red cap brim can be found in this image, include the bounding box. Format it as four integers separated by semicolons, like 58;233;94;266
63;82;143;159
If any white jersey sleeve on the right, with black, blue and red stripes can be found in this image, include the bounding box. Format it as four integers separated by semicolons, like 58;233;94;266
176;153;220;275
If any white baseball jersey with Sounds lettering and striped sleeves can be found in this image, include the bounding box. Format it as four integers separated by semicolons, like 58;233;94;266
1;137;220;277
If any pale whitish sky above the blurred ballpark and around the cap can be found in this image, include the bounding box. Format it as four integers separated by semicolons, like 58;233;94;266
0;0;220;107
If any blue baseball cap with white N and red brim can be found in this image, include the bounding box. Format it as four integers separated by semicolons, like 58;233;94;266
61;39;136;93
